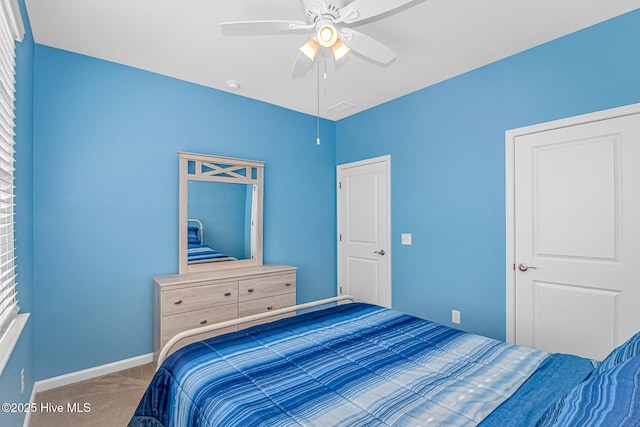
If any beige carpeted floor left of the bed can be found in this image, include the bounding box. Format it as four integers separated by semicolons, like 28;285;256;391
29;363;155;427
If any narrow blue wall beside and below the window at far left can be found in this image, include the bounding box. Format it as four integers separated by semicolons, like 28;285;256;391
0;0;34;426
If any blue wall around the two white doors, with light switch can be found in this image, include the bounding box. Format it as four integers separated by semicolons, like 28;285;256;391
336;11;640;339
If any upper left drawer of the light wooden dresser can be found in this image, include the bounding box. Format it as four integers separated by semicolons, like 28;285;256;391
161;282;238;316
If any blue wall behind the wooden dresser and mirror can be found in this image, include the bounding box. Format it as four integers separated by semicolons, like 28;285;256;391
34;45;336;379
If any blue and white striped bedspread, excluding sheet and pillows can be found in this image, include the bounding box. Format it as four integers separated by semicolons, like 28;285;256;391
129;303;548;427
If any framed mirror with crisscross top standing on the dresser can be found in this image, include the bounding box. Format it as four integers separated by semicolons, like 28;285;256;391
178;152;264;274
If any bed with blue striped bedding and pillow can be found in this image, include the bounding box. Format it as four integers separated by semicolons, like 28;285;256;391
129;302;640;427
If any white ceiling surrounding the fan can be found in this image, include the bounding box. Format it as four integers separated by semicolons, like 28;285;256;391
26;0;640;120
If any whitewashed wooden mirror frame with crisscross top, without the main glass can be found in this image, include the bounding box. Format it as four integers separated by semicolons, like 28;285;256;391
178;152;264;274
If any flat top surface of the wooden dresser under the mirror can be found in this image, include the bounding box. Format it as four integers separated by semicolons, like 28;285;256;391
153;264;297;286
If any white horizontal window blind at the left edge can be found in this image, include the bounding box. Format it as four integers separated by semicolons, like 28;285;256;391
0;0;24;337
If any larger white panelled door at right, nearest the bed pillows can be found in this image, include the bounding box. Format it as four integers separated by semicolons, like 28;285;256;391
513;107;640;359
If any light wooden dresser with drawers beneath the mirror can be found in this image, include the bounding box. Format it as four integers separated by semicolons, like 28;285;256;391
153;264;296;360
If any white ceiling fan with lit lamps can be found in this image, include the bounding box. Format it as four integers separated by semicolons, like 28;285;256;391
220;0;419;78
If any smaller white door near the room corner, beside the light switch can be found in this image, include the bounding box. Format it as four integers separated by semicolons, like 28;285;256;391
337;156;391;307
